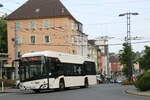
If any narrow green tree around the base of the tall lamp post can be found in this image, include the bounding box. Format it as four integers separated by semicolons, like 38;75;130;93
119;43;135;80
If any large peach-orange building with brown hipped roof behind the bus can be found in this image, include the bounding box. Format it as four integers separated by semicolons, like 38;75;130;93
6;0;87;63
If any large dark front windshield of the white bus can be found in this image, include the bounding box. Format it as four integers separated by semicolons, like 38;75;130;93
19;57;48;81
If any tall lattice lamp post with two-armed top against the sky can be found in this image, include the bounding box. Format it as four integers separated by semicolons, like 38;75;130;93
119;12;139;80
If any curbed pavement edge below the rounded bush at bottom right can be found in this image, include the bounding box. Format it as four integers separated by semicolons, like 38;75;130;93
126;89;150;96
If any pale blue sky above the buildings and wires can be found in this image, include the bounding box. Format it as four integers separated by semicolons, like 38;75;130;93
0;0;150;53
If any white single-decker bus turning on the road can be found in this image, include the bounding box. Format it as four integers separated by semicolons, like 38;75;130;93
19;51;96;92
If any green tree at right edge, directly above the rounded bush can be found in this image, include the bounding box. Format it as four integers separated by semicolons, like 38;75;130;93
138;46;150;70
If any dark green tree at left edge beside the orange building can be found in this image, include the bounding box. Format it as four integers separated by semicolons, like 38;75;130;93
0;15;7;53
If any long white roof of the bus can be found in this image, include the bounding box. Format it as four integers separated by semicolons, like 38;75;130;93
22;51;94;64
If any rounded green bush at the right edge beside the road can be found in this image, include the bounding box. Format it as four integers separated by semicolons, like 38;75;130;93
135;71;150;91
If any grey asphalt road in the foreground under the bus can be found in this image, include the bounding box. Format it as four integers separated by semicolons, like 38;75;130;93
0;84;150;100
